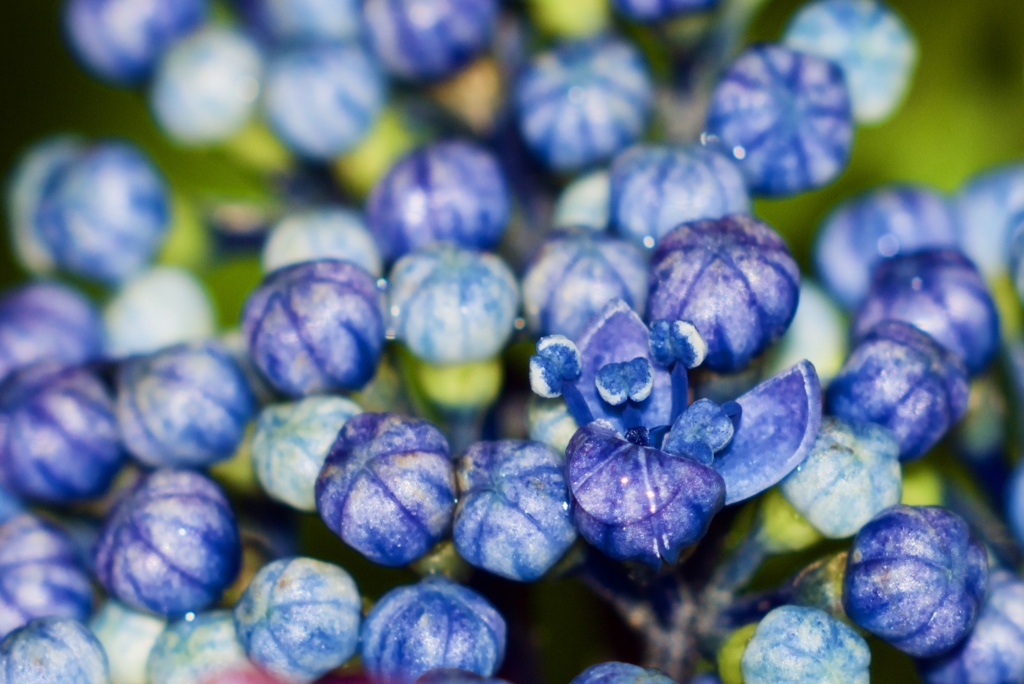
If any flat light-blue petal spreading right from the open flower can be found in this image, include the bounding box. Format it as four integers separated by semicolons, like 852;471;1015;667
714;360;821;505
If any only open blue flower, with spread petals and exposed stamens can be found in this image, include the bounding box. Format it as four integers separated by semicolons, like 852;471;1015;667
530;300;821;567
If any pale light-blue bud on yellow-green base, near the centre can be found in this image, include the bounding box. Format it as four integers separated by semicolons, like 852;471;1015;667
388;244;519;365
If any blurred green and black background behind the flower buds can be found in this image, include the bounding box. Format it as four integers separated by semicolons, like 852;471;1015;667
0;0;1024;682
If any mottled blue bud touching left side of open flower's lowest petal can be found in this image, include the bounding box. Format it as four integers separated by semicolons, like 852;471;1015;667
453;440;577;582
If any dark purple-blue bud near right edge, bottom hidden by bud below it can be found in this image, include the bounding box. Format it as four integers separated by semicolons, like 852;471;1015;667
853;249;999;375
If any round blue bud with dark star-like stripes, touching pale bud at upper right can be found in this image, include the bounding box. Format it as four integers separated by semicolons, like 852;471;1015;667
707;43;853;196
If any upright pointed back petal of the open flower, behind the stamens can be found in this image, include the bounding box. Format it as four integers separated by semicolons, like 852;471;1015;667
577;299;672;432
